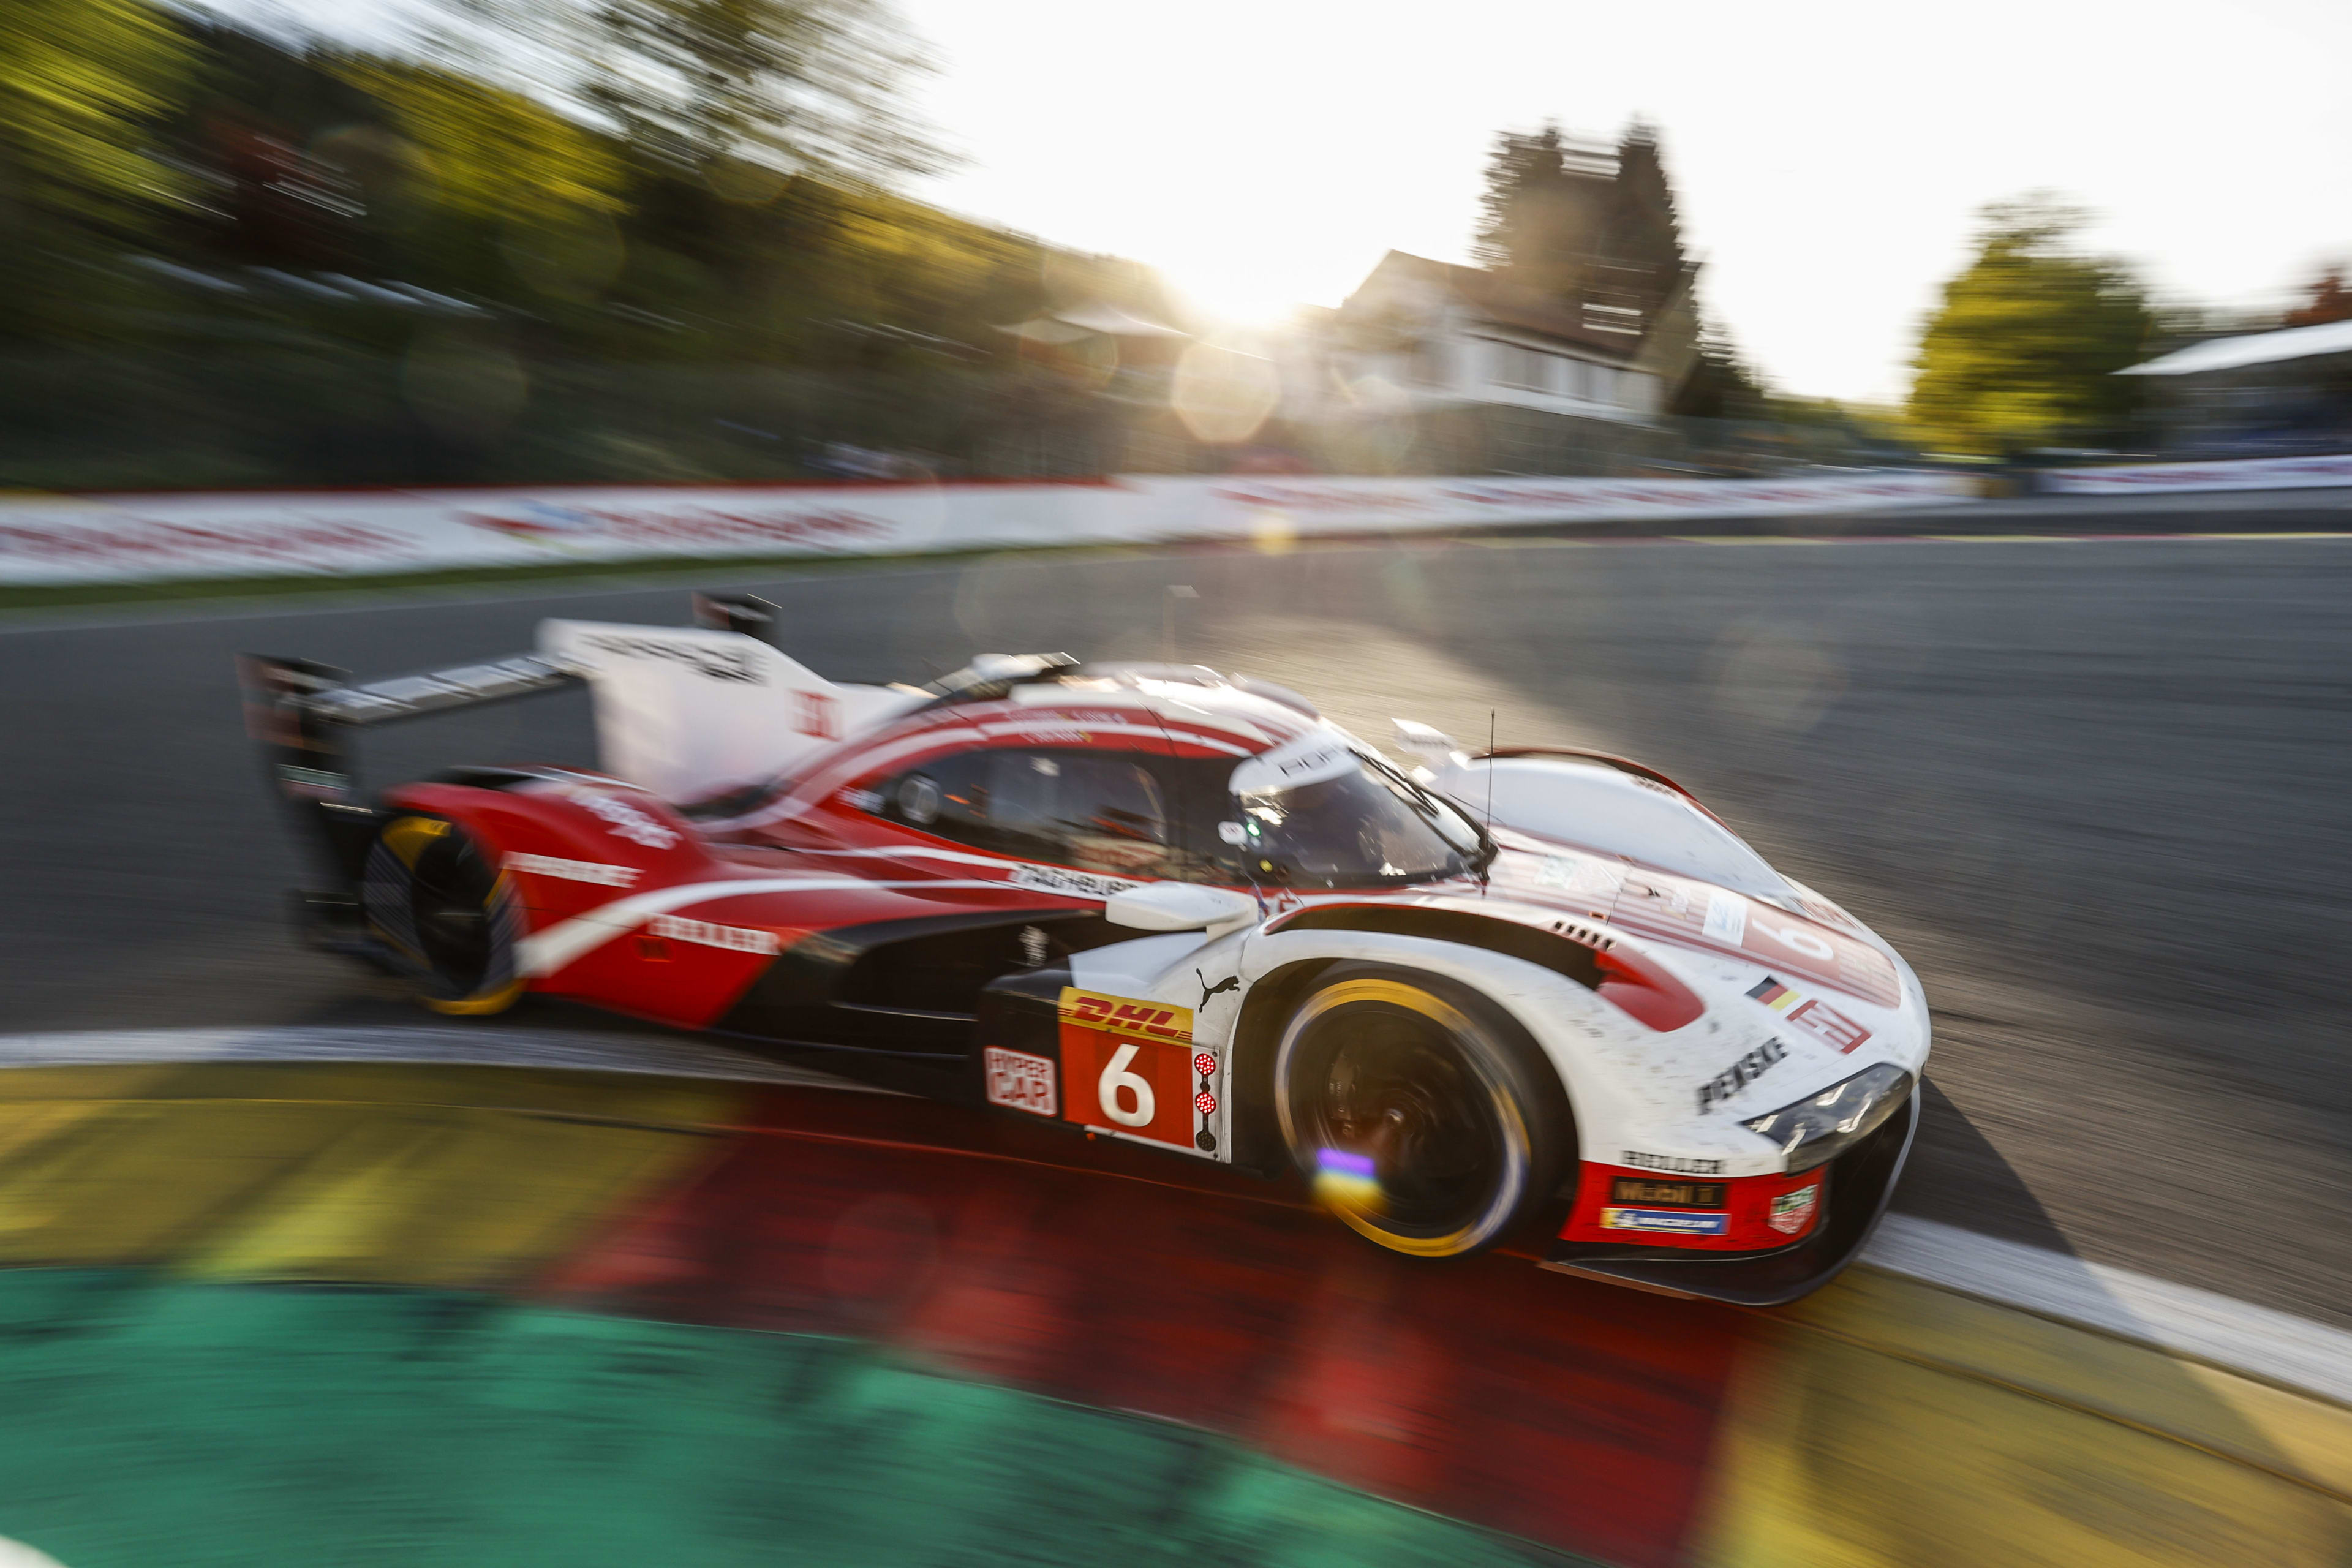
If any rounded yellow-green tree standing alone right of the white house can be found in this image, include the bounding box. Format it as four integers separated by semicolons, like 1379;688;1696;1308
1907;197;2152;454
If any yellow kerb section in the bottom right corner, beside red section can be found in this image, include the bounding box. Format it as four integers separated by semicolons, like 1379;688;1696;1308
1696;1270;2352;1568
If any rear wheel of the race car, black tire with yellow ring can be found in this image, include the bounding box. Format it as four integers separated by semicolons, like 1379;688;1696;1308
360;811;522;1016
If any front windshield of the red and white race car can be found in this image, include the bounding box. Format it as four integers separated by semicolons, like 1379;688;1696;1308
1235;752;1482;889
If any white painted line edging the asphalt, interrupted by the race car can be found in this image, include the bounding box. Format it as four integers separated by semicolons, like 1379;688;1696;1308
0;1025;2352;1403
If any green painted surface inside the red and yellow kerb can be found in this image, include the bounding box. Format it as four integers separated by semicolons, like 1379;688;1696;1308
0;1270;1599;1568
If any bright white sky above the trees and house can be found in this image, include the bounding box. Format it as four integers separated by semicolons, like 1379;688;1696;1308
211;0;2352;402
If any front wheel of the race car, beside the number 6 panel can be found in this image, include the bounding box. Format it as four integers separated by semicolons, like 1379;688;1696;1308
1275;964;1576;1257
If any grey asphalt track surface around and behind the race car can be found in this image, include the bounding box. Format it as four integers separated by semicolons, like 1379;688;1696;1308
0;508;2352;1326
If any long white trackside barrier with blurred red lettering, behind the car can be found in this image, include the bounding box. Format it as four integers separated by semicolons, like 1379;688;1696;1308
0;472;1973;586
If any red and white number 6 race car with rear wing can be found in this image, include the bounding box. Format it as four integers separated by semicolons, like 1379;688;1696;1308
243;595;1929;1305
